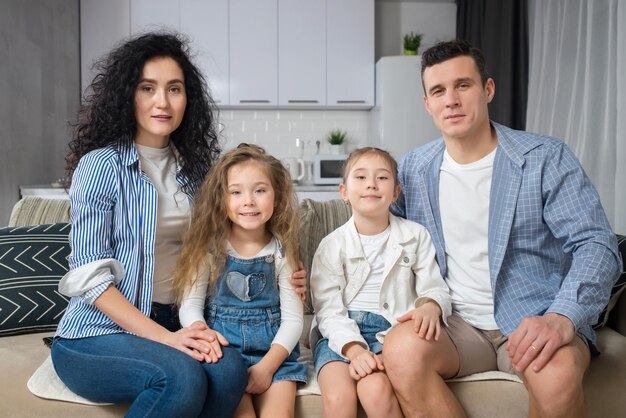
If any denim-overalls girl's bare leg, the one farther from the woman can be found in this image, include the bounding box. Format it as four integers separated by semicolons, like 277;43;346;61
254;380;296;418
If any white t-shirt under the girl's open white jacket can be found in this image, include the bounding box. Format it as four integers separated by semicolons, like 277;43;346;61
347;227;391;314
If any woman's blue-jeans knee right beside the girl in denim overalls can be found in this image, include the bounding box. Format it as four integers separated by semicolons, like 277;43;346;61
200;346;246;418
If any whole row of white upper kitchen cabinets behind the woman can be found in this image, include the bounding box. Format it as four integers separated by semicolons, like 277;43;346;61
81;0;374;109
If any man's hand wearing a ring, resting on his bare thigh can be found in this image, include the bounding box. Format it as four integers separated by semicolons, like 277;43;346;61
505;313;576;372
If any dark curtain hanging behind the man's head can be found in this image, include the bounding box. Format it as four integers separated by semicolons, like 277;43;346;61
456;0;529;130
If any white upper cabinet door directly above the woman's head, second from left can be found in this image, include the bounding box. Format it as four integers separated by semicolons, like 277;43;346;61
130;0;180;35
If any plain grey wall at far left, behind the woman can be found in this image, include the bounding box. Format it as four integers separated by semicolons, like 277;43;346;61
0;0;80;226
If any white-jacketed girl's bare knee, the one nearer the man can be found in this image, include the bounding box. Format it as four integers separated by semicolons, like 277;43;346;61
356;372;402;418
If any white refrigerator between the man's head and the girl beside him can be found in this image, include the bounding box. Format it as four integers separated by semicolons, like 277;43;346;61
370;55;441;160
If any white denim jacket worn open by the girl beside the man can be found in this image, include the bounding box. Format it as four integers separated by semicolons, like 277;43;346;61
310;214;452;357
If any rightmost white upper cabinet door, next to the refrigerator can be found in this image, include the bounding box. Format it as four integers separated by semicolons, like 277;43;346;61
326;0;375;109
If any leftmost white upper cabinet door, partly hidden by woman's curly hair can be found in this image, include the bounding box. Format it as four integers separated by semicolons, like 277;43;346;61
80;0;130;93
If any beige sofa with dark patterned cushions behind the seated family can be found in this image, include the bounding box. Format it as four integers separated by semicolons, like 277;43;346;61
0;197;626;418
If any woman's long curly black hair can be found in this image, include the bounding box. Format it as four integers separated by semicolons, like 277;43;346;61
65;32;221;193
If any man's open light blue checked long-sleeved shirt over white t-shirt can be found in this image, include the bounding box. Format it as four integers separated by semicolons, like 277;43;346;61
392;122;621;344
